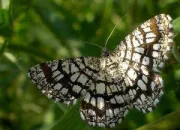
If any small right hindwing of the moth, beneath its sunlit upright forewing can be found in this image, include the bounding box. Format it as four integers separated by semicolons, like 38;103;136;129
132;74;164;113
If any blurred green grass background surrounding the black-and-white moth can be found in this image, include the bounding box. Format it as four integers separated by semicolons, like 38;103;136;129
0;0;180;130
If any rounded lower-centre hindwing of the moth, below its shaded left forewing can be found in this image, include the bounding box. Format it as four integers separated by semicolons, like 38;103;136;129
80;77;130;128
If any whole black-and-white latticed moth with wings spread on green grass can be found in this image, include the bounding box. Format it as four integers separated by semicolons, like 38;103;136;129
28;14;174;128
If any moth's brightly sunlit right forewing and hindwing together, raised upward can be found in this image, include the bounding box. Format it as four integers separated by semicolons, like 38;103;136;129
115;14;173;113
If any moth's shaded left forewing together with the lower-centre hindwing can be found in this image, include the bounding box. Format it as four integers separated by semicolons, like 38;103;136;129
28;57;129;127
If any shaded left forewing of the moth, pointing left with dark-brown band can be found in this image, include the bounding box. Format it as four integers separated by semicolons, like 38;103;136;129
28;57;99;105
